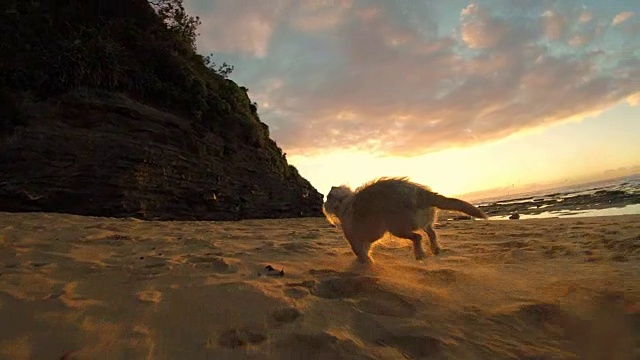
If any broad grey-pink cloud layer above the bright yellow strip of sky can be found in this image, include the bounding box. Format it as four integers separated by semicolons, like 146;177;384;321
192;0;640;156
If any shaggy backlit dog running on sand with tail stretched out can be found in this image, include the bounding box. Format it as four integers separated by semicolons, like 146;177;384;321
322;177;487;263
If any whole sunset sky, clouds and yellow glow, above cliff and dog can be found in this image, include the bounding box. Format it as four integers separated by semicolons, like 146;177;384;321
185;0;640;200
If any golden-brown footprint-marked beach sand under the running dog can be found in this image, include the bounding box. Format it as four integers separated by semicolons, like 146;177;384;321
0;213;640;359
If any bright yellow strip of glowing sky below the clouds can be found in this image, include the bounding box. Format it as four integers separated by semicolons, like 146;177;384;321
288;104;640;200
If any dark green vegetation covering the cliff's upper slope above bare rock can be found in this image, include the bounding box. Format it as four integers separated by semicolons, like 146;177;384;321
0;0;276;146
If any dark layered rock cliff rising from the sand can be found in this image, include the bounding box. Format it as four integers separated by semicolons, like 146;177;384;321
0;0;323;220
